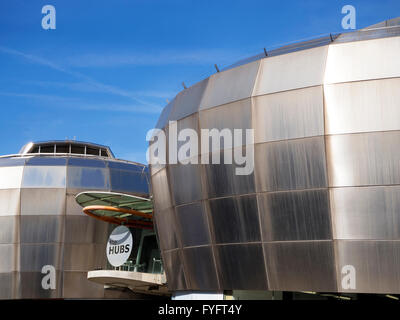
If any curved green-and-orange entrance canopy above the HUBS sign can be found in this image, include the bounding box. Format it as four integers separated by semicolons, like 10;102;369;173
75;191;153;229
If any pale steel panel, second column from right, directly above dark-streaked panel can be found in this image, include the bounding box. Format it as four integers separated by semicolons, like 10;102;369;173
253;86;324;143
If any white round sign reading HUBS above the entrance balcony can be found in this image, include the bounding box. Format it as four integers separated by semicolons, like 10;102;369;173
107;226;132;267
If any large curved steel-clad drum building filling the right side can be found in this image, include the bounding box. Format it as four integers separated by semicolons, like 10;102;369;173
151;18;400;293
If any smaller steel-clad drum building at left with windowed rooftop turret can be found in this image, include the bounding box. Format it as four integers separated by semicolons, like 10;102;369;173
0;141;148;299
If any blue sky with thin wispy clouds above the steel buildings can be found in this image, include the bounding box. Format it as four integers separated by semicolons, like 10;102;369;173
0;0;400;162
